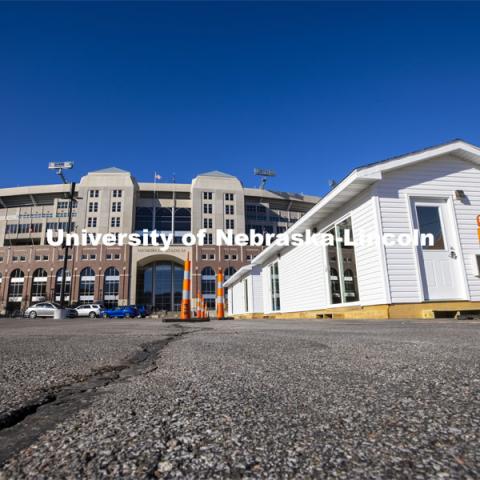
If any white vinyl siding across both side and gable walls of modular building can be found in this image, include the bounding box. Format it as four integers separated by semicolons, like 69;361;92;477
228;154;480;314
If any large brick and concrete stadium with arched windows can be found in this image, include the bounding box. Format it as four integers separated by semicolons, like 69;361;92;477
0;168;319;312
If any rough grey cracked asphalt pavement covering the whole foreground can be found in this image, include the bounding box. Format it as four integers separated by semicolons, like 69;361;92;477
0;319;480;480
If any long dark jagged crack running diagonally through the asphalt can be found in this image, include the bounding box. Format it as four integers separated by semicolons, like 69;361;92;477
0;324;203;466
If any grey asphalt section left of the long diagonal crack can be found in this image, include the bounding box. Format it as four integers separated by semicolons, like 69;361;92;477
0;318;180;416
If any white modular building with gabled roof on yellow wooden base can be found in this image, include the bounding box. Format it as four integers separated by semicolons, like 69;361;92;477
227;140;480;318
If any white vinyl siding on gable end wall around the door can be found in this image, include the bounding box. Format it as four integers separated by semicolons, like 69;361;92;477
375;155;480;303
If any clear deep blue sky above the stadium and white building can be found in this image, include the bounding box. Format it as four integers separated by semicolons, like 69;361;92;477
0;2;480;194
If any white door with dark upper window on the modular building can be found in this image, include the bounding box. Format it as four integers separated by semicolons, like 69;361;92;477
413;200;465;300
